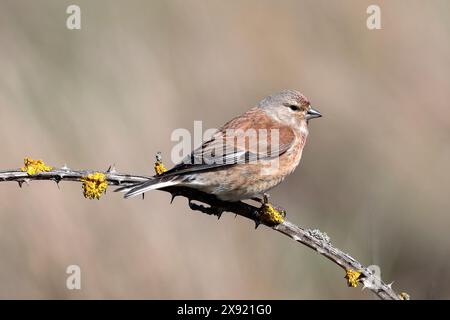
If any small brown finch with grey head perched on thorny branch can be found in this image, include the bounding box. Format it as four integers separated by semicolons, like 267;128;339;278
116;90;322;202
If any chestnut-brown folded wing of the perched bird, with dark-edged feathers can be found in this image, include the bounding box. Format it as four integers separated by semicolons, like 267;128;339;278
163;108;296;176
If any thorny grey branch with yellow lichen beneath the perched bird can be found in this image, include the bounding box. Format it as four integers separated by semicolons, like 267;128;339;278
0;160;409;300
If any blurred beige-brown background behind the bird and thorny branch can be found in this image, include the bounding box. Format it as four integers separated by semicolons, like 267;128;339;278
0;0;450;299
